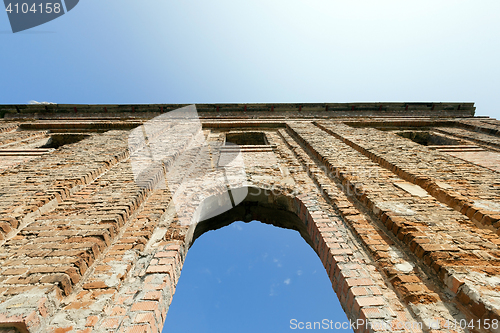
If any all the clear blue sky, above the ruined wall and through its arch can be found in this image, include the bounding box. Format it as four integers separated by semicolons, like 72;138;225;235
0;0;500;332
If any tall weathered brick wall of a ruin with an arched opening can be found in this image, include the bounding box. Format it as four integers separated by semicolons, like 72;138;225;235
0;103;500;333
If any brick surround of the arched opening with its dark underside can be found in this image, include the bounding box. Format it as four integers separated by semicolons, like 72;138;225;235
90;186;411;332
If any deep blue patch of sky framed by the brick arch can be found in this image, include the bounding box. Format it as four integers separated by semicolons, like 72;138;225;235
163;221;352;333
